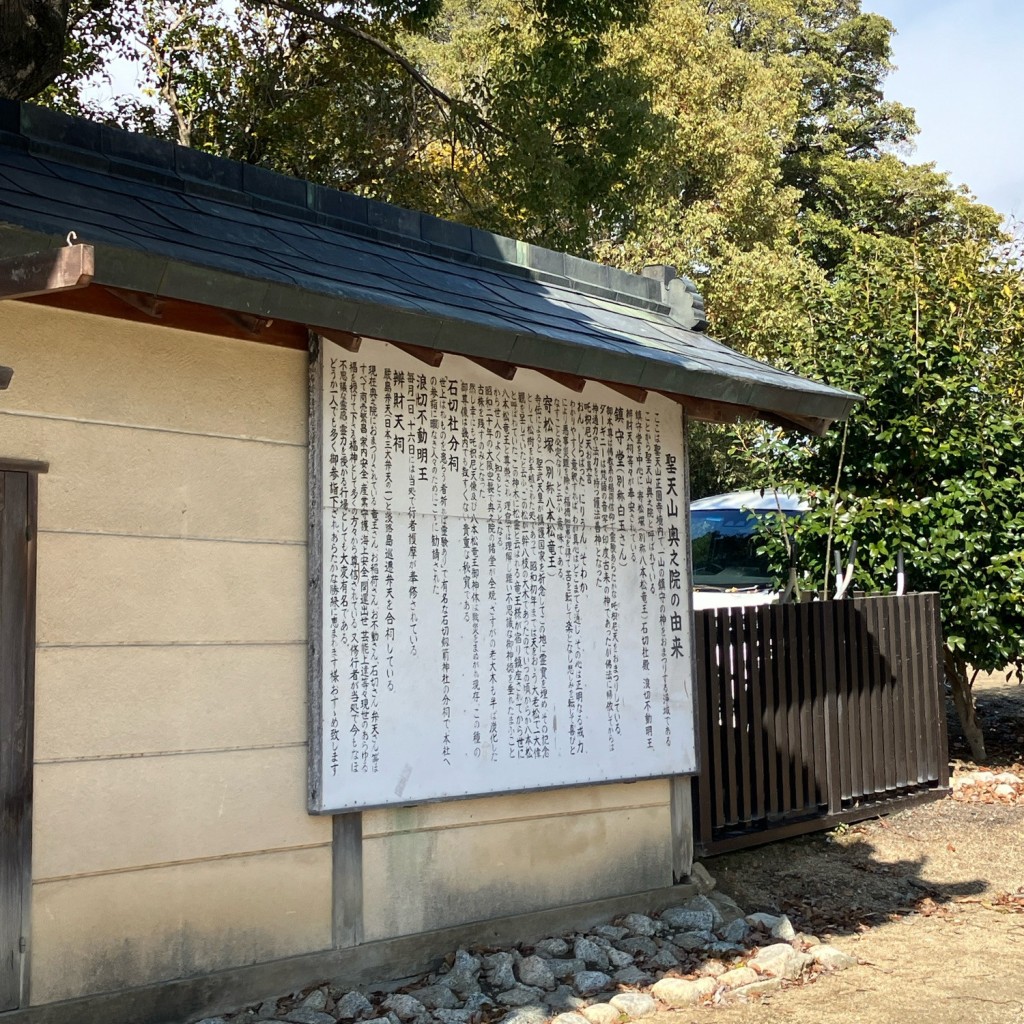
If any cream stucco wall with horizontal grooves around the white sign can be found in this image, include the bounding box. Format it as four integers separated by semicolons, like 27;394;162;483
0;302;671;1004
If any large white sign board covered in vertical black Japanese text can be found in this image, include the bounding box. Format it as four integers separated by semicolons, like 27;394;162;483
310;340;696;812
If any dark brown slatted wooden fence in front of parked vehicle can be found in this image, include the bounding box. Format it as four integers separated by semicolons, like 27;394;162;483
694;594;949;854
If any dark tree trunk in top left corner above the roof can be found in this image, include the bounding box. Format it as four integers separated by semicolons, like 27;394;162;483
0;0;70;99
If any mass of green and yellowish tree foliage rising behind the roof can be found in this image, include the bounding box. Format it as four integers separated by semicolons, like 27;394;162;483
36;0;1024;720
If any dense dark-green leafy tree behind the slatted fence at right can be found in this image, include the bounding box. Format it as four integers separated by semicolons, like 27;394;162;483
745;201;1024;759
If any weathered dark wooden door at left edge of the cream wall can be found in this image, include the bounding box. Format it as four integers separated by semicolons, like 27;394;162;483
0;464;36;1012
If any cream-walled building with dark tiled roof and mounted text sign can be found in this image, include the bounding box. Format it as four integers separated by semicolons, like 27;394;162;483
0;104;856;1022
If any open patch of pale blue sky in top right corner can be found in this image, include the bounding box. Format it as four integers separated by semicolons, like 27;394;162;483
861;0;1024;220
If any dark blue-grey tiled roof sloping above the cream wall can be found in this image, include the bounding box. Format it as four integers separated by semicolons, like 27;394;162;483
0;103;857;429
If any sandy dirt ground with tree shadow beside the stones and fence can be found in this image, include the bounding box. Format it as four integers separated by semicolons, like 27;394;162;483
652;677;1024;1024
